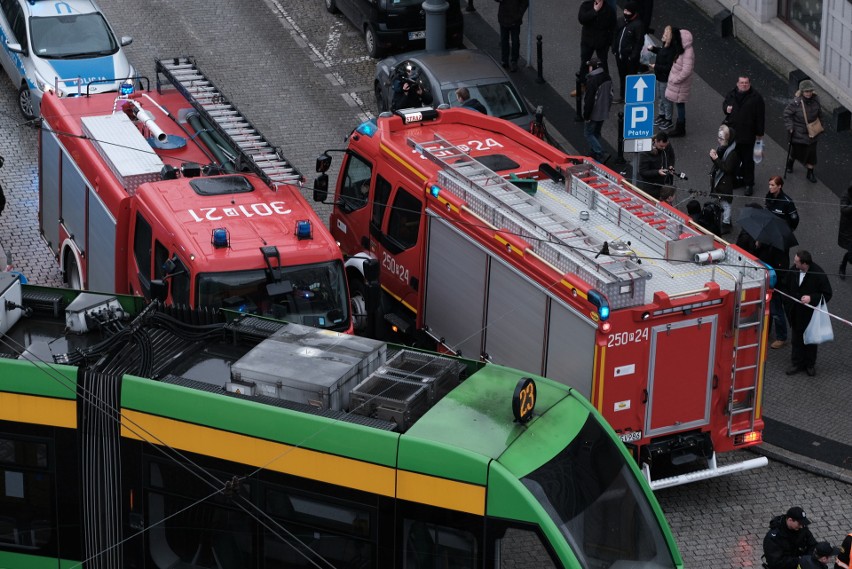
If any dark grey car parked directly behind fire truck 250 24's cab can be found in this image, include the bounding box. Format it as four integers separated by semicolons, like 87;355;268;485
374;49;532;129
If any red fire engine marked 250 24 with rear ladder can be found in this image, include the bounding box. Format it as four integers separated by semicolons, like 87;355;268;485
314;108;770;487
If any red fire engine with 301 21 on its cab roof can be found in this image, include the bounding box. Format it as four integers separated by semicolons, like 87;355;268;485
39;58;352;331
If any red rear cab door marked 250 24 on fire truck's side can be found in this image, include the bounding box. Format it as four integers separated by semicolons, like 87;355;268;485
370;174;423;312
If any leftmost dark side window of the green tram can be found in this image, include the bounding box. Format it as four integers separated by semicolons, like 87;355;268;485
0;437;54;550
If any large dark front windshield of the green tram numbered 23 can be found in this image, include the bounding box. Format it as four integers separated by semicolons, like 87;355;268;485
522;416;675;569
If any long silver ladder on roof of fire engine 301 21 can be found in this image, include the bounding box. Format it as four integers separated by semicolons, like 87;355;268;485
156;57;304;189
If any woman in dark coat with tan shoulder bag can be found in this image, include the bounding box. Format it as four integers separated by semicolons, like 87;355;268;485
784;79;822;183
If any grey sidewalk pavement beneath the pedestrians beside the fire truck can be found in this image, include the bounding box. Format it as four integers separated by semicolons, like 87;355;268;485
465;0;852;483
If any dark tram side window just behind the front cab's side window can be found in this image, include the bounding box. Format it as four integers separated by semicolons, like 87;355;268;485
403;519;479;569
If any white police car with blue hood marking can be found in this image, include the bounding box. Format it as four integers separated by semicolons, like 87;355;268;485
0;0;136;118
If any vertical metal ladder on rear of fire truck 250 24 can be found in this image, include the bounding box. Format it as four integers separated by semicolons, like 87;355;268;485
728;272;766;436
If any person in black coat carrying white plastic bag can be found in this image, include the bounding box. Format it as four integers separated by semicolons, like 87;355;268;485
784;249;831;377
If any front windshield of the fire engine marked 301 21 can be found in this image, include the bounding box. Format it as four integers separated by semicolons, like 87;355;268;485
197;261;349;331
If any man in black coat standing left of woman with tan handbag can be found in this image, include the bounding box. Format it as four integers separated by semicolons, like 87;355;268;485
720;75;766;196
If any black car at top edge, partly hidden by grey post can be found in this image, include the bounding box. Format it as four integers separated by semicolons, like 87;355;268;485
325;0;464;57
